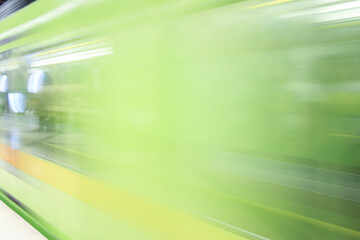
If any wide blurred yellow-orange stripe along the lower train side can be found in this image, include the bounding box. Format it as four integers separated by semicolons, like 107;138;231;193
0;143;247;240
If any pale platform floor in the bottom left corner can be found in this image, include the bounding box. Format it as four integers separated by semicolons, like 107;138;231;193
0;201;46;240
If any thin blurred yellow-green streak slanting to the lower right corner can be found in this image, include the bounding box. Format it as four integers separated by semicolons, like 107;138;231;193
206;189;360;239
